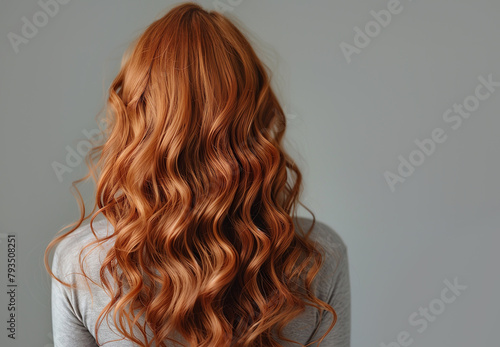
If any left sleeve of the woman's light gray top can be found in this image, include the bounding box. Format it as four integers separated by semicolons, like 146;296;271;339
51;240;98;347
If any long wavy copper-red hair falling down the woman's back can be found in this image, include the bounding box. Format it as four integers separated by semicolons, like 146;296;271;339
44;3;337;347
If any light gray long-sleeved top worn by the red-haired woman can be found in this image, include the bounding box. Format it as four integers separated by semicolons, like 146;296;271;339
51;218;351;347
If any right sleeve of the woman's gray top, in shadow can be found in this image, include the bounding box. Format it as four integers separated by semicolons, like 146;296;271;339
308;240;351;347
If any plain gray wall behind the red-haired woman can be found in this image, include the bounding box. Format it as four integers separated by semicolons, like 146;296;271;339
0;0;500;347
